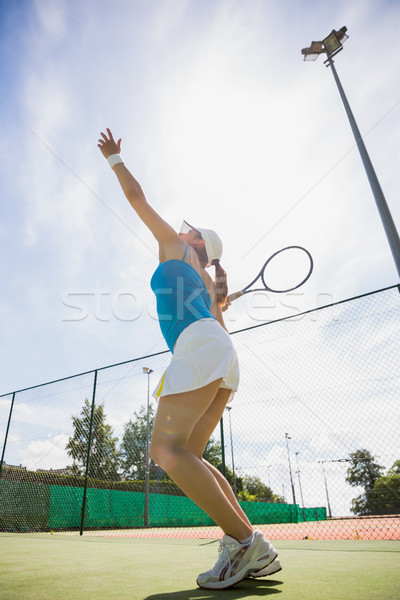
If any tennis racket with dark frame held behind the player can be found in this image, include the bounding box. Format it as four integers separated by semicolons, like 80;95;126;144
227;246;314;302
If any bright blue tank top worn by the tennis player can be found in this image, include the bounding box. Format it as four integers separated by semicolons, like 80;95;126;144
150;246;215;352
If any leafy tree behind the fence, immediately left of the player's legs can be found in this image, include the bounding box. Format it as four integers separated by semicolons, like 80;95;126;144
120;406;162;481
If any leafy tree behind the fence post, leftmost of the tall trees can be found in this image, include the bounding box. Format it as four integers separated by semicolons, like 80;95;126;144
66;398;120;481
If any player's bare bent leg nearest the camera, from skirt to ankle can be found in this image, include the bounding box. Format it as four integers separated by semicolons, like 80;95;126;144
151;379;253;540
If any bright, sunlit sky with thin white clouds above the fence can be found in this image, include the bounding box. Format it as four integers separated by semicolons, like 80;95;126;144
0;0;400;516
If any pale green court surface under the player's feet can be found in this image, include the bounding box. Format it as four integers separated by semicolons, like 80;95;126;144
0;533;400;600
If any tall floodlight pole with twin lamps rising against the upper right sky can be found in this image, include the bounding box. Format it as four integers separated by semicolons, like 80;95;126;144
302;27;400;278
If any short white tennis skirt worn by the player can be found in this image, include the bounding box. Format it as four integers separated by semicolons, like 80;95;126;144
153;318;239;398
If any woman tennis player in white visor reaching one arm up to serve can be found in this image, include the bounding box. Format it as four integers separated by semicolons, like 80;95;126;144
98;129;280;590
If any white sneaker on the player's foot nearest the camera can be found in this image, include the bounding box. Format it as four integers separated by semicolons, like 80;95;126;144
197;531;278;590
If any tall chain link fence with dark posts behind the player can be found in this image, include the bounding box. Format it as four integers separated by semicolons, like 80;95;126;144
0;286;400;539
